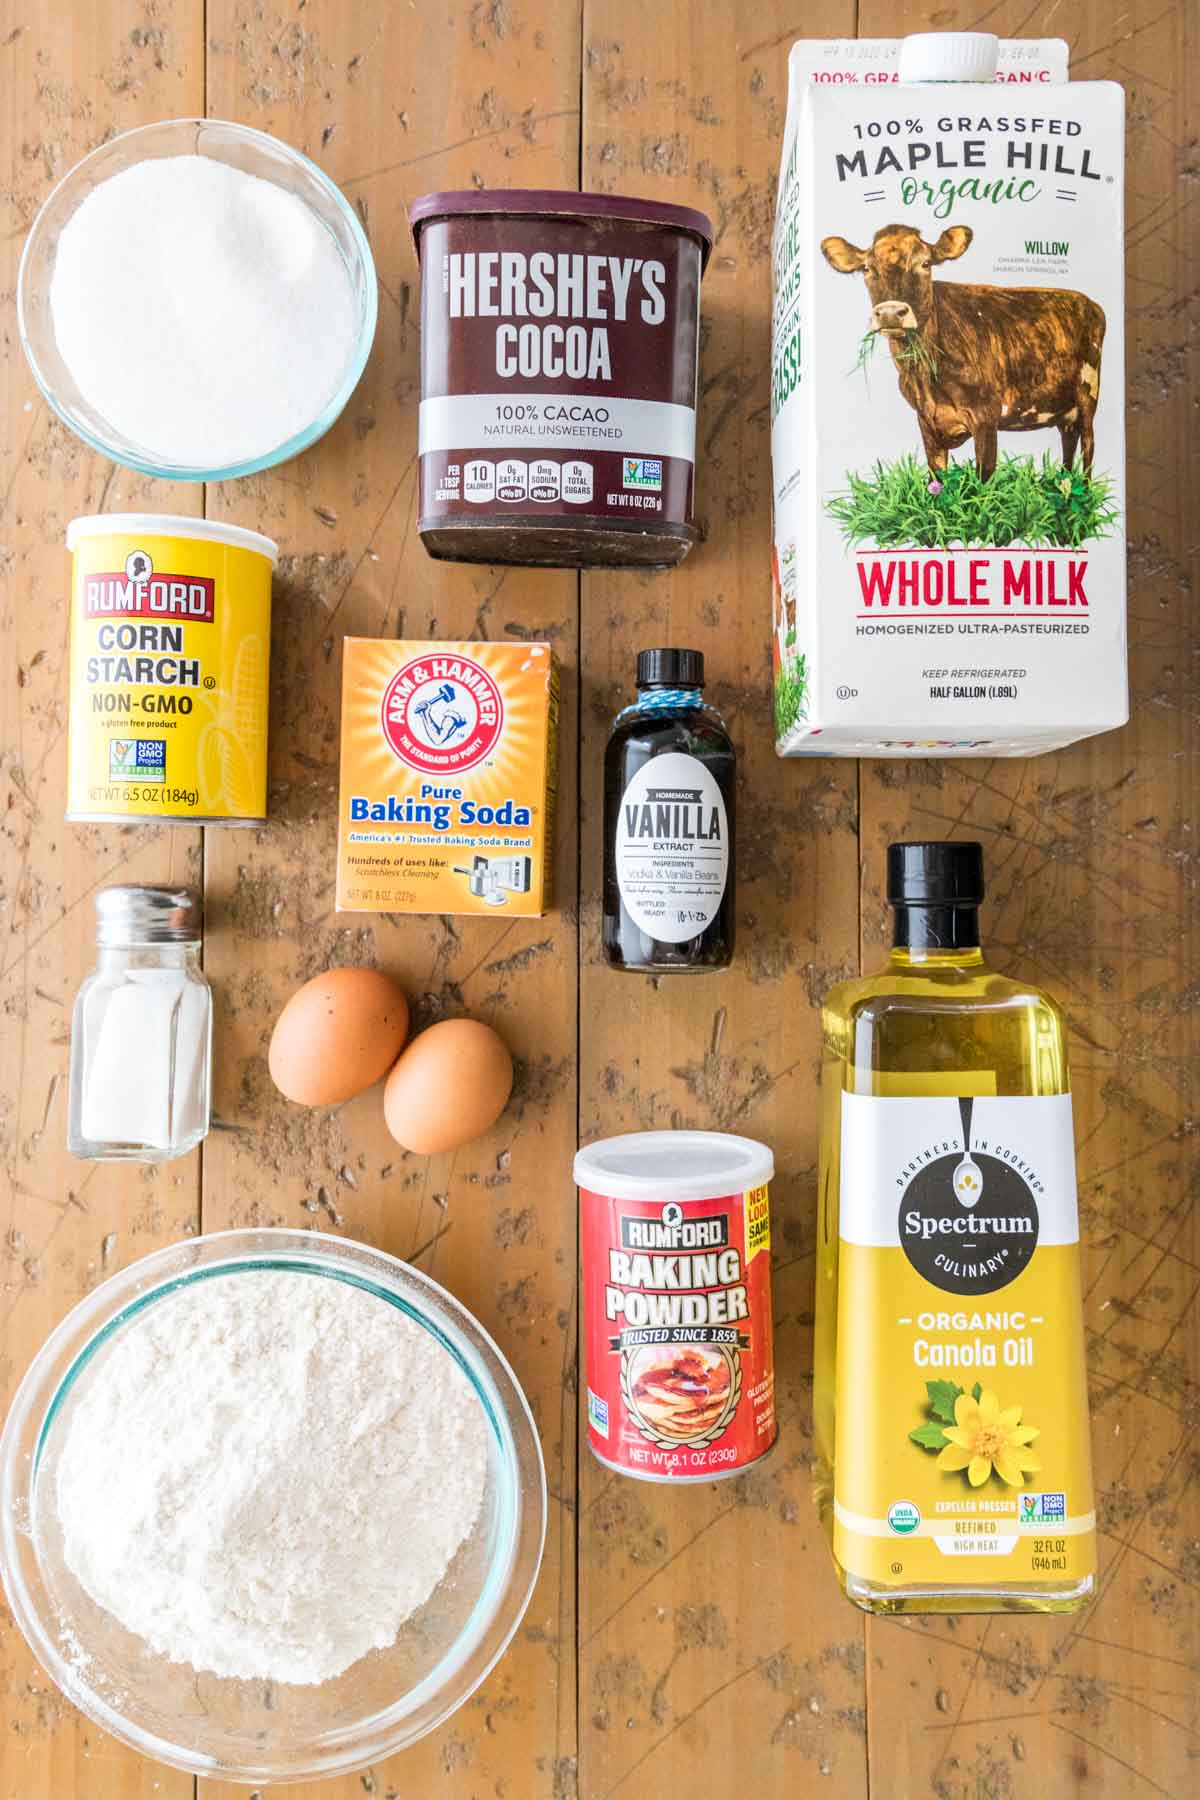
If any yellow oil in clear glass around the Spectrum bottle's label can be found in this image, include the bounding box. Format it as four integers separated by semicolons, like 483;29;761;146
813;949;1096;1613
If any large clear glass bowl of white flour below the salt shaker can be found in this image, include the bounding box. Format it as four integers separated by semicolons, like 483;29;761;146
0;1231;545;1786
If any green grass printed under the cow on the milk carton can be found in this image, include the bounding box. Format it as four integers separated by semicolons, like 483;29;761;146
826;452;1119;549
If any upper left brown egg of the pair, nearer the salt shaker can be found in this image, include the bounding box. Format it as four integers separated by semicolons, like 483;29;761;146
266;968;408;1107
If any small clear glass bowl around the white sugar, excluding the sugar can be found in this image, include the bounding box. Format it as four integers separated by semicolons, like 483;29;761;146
16;119;378;481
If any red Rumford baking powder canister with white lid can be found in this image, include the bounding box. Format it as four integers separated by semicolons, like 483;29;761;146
576;1130;775;1481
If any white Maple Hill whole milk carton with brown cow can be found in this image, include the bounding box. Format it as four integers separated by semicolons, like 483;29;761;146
772;34;1128;756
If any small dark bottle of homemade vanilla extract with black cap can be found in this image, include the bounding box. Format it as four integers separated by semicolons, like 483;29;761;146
604;650;736;976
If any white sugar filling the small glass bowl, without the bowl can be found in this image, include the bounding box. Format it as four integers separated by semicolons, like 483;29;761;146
50;157;358;468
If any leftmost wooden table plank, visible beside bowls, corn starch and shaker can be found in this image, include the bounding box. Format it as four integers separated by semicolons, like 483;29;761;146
0;0;203;1800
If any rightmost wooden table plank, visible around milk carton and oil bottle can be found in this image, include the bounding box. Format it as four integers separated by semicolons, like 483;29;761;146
860;0;1200;1800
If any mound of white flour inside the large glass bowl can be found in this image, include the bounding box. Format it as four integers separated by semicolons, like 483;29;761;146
56;1271;488;1683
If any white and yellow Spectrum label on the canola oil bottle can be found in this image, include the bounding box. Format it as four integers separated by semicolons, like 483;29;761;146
833;1094;1096;1588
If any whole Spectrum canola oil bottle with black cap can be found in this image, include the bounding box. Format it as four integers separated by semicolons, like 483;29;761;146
815;842;1096;1613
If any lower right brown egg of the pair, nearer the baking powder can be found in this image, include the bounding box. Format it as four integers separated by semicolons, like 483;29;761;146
383;1019;513;1156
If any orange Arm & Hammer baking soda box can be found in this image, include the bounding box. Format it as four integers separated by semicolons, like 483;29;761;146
336;637;558;916
